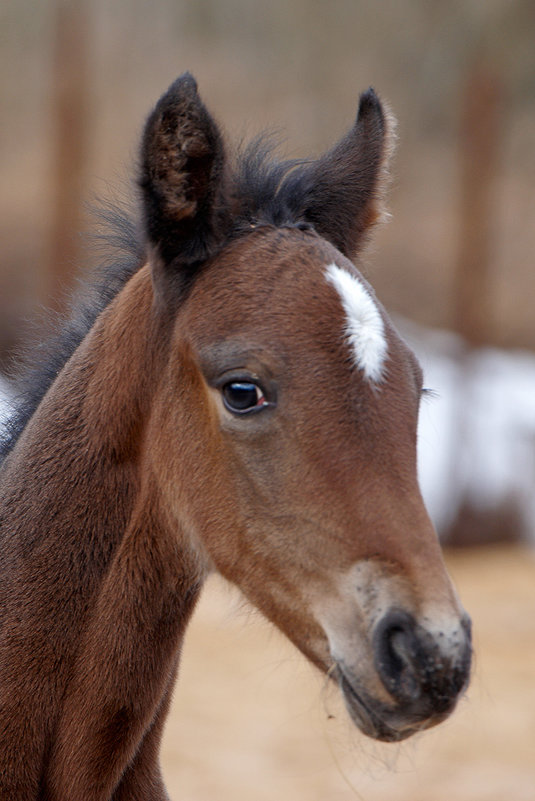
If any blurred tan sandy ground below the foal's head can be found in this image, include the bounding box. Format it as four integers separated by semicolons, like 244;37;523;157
163;548;535;801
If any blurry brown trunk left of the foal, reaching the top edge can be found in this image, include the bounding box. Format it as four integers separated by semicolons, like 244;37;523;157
45;0;90;311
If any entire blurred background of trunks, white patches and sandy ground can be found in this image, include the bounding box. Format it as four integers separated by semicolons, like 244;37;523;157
0;0;535;801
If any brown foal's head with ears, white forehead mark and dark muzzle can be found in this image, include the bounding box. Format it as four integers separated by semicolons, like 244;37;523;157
141;75;470;741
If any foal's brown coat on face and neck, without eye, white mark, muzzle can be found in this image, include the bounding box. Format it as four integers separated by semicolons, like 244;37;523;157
0;73;466;801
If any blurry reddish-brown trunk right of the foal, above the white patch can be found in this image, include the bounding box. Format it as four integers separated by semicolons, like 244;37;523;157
454;61;501;345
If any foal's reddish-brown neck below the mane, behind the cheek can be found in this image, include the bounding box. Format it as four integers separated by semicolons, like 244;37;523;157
0;269;207;799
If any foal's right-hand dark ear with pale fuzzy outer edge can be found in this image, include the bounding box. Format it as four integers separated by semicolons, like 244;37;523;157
286;89;394;258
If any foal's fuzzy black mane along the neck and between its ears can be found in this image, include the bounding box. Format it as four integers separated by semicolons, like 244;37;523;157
0;135;322;464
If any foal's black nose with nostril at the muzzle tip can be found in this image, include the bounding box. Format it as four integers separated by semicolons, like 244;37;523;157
374;609;471;714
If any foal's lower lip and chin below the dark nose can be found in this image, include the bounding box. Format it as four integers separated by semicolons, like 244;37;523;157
335;664;434;743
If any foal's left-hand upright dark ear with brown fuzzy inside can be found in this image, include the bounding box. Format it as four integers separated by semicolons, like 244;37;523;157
139;73;225;273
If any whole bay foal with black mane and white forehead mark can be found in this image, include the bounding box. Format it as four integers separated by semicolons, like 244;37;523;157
0;75;470;801
